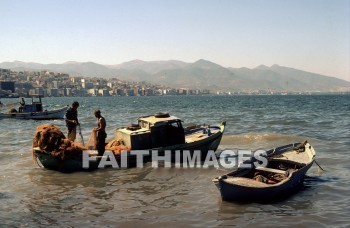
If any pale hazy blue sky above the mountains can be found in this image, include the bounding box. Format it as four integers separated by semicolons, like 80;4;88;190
0;0;350;81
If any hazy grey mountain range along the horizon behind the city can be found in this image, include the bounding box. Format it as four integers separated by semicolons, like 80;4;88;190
0;59;350;92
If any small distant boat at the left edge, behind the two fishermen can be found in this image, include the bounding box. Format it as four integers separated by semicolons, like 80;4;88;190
0;96;68;120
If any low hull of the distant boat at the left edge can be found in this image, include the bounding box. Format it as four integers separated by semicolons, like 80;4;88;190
0;107;68;120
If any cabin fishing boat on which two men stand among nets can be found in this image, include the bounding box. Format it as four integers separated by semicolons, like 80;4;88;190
33;113;226;172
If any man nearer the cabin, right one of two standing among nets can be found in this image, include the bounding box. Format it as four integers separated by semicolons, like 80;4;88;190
93;110;107;155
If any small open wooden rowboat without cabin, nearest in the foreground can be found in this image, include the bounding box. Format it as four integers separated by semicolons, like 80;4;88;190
213;142;316;201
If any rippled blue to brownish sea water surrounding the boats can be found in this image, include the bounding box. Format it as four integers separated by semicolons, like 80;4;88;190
0;95;350;227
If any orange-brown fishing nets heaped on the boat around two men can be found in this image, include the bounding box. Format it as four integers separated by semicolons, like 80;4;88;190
33;124;131;160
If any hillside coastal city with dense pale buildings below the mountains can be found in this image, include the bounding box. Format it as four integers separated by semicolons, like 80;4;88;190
0;69;210;97
